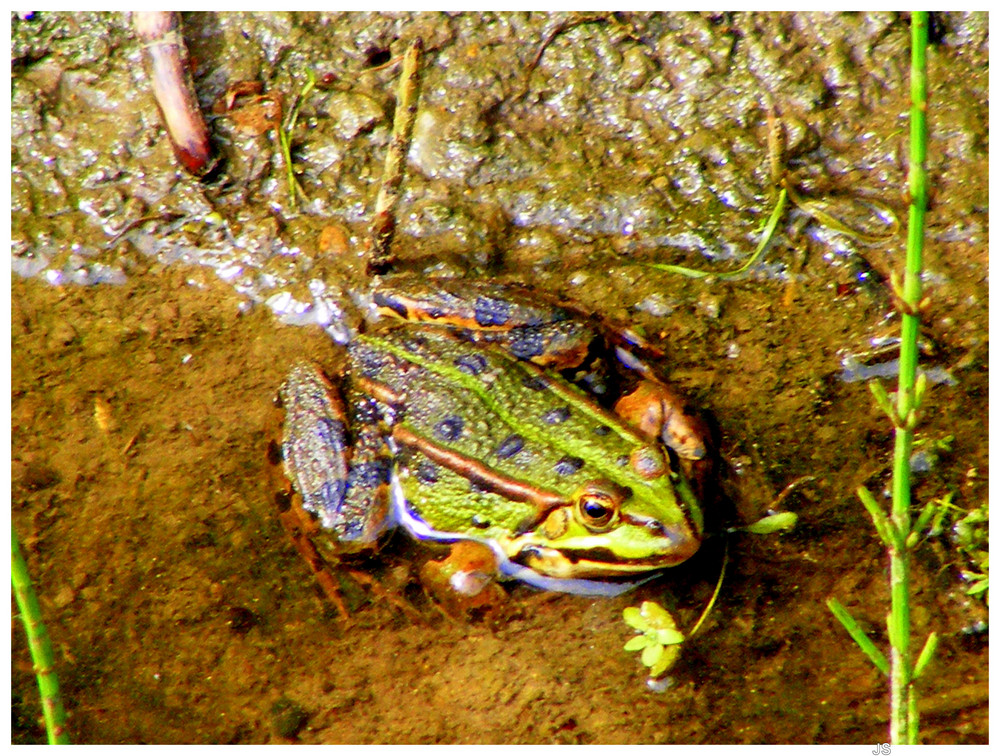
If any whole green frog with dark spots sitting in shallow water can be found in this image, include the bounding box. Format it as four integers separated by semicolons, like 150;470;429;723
271;280;709;595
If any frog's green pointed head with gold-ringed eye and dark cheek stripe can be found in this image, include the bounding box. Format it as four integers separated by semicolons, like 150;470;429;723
504;476;702;587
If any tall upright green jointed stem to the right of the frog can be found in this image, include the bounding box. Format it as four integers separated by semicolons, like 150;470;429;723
889;11;927;744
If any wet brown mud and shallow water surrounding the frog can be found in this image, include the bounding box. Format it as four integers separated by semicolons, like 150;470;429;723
11;13;988;743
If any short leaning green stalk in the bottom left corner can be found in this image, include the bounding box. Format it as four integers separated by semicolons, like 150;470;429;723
10;527;69;745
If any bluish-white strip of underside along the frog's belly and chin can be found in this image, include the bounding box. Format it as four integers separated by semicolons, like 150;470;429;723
389;469;659;596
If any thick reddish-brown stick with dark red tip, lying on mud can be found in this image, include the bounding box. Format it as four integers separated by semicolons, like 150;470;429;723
132;11;212;176
